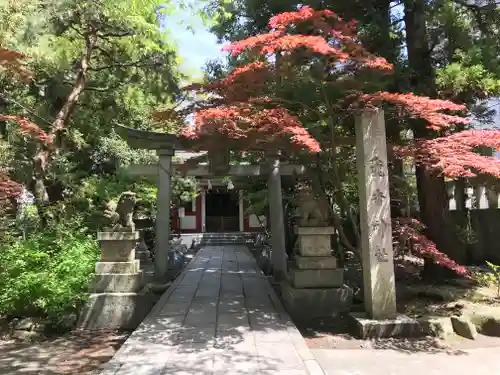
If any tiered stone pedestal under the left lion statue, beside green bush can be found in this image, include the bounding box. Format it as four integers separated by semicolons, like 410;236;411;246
78;232;151;330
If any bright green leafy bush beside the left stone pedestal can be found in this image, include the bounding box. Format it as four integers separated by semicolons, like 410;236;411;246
0;225;99;327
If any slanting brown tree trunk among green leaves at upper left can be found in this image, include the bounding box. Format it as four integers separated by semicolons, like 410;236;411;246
32;27;97;226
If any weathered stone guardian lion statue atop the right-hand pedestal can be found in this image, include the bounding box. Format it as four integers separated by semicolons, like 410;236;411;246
297;187;328;227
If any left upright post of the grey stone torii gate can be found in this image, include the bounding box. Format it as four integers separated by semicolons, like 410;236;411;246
154;149;174;283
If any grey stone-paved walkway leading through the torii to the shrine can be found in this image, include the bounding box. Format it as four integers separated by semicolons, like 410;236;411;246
101;246;323;375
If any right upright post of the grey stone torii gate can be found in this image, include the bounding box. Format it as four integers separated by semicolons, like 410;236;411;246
267;155;287;281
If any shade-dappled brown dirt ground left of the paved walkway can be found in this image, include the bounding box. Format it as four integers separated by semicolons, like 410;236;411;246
0;332;129;375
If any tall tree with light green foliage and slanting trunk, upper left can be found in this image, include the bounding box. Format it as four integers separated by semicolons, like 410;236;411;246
0;0;181;223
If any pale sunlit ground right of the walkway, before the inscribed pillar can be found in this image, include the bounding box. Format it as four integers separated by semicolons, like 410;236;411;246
302;321;500;375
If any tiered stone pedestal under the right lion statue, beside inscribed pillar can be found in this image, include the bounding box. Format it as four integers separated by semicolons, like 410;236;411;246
281;227;352;320
